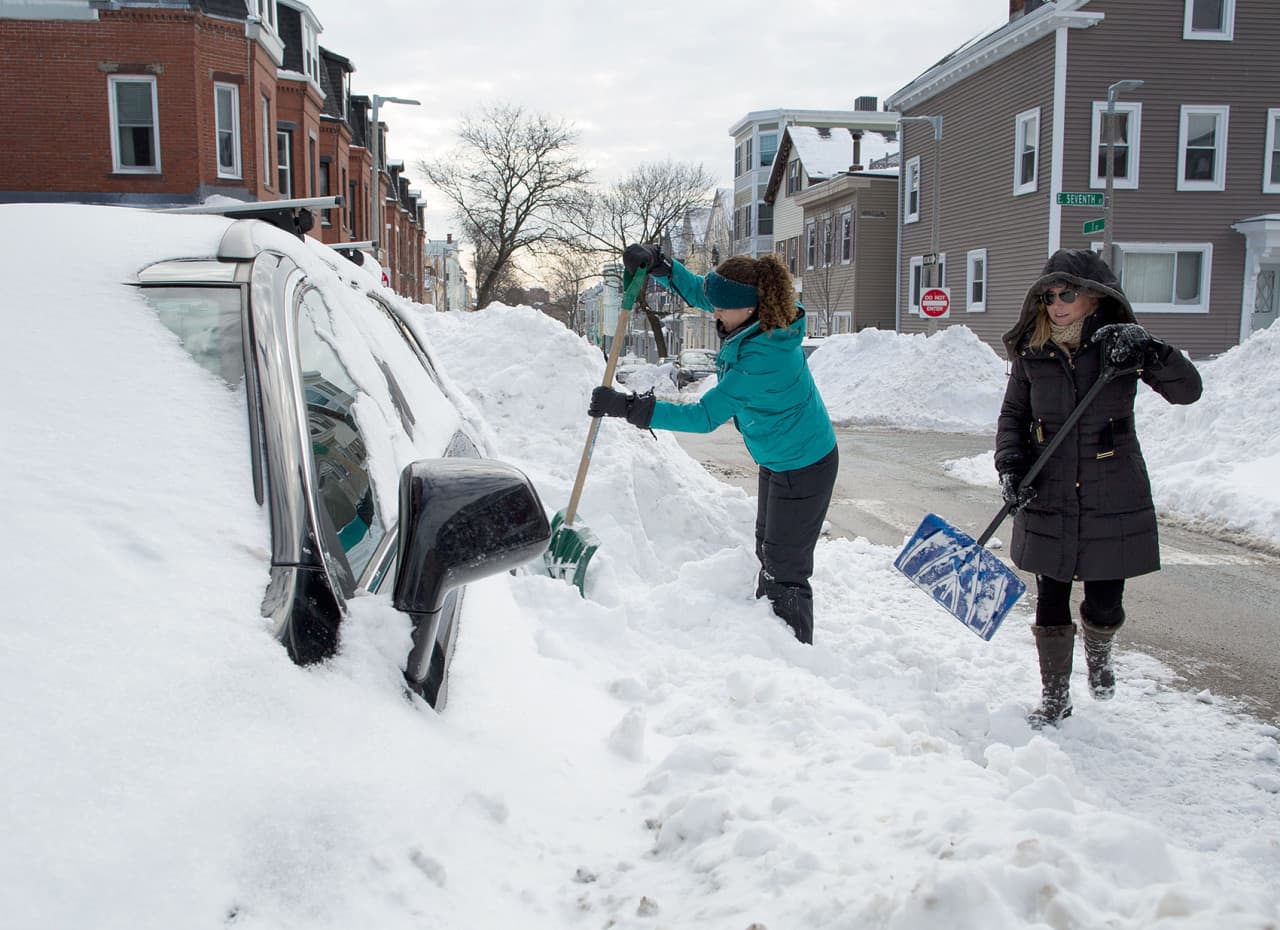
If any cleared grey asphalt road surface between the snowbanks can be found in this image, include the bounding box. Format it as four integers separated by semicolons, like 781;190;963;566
675;425;1280;721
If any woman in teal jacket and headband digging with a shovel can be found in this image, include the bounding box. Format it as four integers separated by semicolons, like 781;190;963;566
588;244;840;643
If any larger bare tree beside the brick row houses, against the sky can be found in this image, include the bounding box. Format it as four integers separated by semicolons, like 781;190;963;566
419;104;589;307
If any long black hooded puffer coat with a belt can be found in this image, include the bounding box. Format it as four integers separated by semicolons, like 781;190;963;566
996;249;1201;581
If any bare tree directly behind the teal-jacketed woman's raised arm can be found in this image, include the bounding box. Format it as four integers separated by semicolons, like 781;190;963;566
566;160;716;357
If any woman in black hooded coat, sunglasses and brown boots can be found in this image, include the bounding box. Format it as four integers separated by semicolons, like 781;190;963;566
996;249;1201;728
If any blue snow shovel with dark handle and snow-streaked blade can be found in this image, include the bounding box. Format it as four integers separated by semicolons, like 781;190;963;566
893;366;1137;641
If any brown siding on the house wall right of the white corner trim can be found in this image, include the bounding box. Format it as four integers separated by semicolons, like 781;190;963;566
1062;0;1280;357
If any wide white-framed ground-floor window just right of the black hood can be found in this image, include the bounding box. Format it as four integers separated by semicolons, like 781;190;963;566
1115;242;1213;313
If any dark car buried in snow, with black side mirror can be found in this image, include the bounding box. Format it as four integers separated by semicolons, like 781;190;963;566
8;205;550;709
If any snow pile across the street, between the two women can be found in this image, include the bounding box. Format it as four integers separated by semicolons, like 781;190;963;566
809;326;1006;432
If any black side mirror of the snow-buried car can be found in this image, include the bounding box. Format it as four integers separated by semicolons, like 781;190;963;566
393;458;552;614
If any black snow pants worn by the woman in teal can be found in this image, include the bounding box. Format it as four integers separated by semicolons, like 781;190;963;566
755;448;840;643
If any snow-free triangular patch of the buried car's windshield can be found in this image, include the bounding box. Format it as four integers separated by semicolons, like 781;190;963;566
142;287;244;388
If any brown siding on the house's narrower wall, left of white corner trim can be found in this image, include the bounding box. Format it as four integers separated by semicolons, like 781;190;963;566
899;36;1055;347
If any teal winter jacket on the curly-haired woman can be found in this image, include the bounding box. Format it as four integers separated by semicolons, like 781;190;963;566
649;255;836;472
